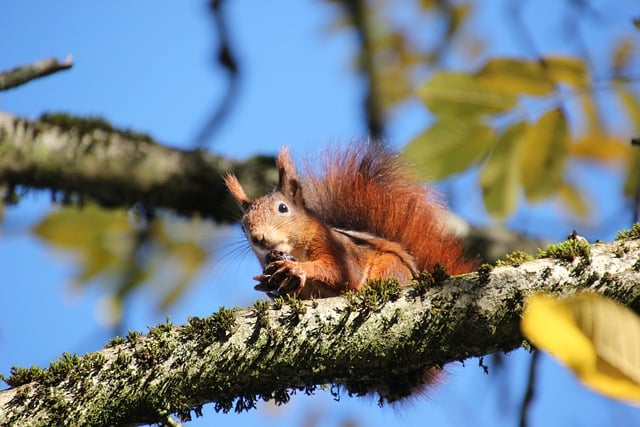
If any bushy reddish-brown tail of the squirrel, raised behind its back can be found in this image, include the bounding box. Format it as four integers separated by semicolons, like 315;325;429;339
301;143;476;275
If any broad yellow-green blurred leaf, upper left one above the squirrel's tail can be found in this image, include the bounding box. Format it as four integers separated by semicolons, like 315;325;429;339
418;72;517;120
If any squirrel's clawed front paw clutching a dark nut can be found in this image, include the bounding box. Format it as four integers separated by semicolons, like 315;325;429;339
254;252;306;296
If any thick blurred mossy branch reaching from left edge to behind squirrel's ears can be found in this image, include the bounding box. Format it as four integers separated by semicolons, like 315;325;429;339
0;112;277;222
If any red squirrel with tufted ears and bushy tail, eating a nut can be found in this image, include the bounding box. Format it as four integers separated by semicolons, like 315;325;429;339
225;143;476;299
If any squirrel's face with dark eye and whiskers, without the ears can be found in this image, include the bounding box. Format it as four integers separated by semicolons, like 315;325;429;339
242;192;304;263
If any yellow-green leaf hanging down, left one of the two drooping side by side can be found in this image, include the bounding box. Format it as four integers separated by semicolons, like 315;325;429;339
480;123;526;218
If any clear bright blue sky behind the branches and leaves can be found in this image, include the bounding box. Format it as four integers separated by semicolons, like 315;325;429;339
0;0;640;426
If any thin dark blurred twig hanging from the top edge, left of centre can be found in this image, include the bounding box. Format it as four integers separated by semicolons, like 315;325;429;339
195;0;239;147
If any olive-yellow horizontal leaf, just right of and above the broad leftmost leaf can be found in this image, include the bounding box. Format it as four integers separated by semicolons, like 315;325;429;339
476;58;555;95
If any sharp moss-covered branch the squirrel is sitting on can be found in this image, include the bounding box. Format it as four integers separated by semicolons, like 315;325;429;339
0;239;640;425
